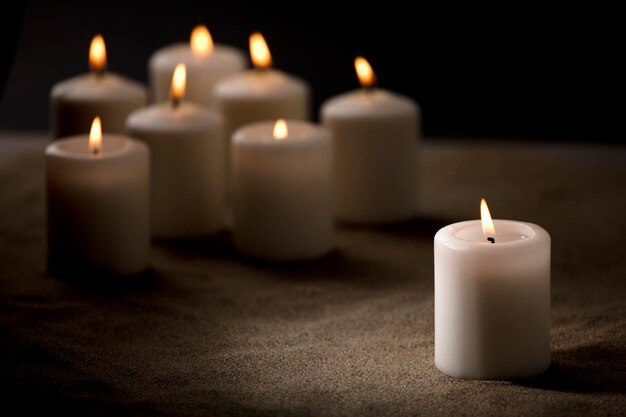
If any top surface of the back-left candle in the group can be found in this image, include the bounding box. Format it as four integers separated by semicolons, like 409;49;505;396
51;72;147;101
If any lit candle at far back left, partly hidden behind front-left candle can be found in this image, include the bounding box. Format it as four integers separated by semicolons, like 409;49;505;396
50;35;147;138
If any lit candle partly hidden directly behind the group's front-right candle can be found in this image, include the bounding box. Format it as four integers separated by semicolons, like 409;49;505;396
214;33;310;137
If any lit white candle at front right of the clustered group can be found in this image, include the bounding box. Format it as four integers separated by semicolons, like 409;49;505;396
233;120;333;260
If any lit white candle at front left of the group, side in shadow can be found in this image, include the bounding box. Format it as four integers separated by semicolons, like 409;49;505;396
46;118;150;275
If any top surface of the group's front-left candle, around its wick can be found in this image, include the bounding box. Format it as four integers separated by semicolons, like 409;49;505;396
46;133;146;160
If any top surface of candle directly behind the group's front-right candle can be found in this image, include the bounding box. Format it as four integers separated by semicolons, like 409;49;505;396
214;69;309;98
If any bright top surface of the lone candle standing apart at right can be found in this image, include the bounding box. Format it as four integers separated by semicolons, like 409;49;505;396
435;219;550;250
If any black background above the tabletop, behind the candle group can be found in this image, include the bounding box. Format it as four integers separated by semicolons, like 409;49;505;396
0;0;626;143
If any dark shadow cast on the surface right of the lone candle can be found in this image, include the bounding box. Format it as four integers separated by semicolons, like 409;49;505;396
515;343;626;394
